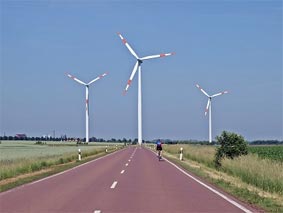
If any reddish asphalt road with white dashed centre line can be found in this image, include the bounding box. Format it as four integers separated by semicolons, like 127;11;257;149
0;147;256;213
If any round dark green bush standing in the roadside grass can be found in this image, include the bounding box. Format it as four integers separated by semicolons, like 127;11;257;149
214;131;248;168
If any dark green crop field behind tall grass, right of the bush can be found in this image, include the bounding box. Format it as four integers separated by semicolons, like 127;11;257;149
249;146;283;163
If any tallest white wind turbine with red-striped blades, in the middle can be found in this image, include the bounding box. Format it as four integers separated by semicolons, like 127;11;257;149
117;33;175;145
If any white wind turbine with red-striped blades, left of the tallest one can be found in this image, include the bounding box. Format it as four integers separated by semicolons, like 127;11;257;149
67;73;107;142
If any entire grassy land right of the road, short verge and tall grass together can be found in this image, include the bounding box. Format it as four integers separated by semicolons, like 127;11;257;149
164;145;283;212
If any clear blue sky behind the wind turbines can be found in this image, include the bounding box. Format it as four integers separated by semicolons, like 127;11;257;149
0;0;283;140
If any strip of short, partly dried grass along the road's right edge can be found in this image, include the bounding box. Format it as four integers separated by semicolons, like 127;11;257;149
163;152;283;212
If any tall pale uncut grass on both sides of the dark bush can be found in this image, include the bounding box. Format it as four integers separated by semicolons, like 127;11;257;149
164;145;283;196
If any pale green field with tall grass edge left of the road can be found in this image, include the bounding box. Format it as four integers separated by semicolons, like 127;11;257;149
0;141;121;181
